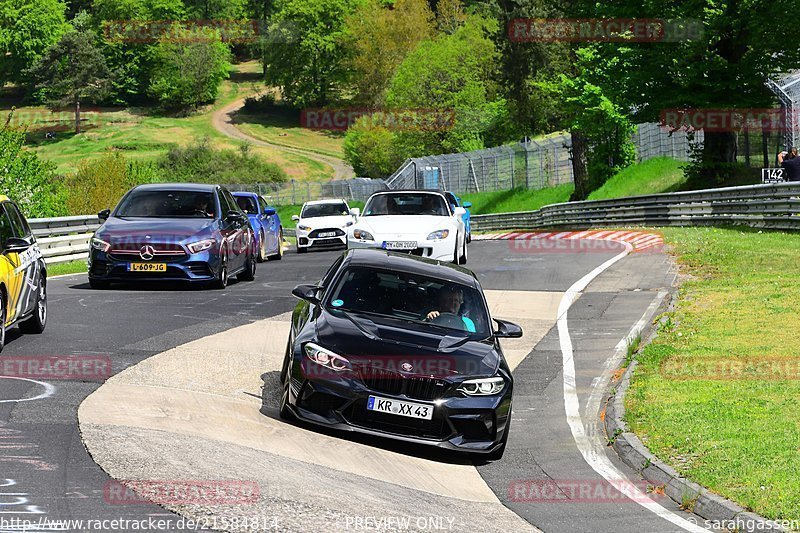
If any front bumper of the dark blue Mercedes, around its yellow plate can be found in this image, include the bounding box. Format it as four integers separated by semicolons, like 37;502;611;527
88;249;220;283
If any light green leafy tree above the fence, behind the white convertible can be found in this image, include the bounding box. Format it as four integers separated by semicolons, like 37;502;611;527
386;15;507;156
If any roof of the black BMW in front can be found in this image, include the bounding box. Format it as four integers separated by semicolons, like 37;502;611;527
343;248;478;288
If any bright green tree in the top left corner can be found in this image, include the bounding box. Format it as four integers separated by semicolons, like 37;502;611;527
0;0;69;87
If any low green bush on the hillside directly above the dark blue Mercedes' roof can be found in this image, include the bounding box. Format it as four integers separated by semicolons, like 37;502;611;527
159;139;288;183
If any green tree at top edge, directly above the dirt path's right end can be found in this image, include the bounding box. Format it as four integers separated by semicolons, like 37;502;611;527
262;0;365;108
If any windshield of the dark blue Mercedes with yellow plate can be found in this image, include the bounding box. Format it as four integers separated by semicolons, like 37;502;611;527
114;190;216;218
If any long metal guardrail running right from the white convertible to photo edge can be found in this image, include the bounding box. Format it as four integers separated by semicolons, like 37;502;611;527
472;182;800;231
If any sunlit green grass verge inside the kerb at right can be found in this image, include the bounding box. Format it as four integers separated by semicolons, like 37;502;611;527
626;228;800;519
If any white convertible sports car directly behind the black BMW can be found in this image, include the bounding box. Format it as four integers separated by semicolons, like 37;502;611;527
347;190;467;265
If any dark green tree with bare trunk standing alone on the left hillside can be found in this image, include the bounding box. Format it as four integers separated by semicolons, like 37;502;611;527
28;24;111;134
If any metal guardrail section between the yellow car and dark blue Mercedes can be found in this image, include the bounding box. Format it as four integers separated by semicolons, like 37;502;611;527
28;215;100;264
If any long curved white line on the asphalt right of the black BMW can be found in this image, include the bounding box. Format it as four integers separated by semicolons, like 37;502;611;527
558;239;707;533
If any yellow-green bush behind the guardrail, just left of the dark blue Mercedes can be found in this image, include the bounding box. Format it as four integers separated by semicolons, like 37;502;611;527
67;153;161;215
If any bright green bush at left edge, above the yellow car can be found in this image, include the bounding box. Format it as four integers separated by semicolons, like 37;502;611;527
0;115;67;218
